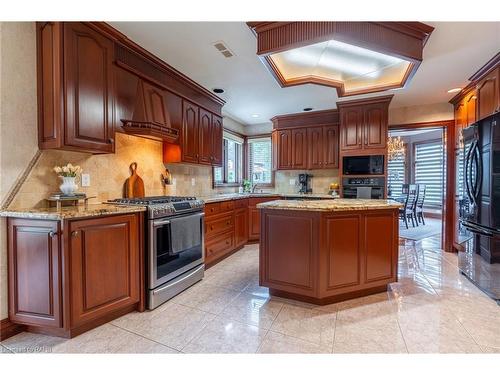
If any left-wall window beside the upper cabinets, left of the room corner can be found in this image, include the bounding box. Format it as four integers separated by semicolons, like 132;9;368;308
213;132;243;186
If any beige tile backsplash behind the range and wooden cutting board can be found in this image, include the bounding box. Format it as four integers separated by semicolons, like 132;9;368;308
10;133;235;208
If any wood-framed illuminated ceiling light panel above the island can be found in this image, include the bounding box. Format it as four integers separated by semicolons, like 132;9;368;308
247;21;434;97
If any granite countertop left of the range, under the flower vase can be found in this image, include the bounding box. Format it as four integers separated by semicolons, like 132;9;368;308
0;204;146;220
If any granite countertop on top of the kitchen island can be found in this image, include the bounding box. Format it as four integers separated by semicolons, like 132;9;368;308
257;198;402;212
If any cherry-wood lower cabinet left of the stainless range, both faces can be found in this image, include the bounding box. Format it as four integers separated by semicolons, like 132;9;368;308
8;213;145;337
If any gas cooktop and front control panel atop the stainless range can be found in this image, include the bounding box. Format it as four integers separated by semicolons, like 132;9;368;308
107;195;205;219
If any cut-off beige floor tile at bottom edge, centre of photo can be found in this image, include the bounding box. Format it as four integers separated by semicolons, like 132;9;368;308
258;331;331;354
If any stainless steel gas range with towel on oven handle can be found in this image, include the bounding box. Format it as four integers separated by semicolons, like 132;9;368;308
108;196;205;309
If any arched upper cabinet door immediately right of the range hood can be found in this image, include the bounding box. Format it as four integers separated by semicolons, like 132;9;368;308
181;100;200;163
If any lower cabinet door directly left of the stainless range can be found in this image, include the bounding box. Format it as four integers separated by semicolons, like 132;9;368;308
67;215;141;327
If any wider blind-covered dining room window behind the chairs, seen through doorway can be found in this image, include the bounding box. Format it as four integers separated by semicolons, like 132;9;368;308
415;141;444;207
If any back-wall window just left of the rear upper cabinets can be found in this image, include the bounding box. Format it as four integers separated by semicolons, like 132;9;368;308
248;137;273;185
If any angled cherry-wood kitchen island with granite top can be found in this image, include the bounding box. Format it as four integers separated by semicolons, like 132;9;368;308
257;199;400;305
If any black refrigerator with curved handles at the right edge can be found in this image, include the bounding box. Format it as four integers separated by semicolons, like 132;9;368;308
457;113;500;299
